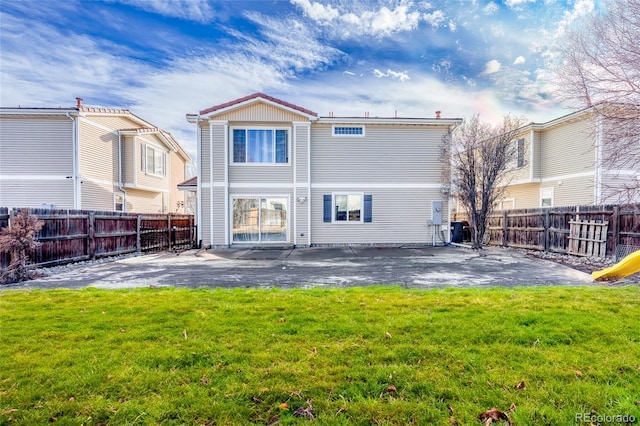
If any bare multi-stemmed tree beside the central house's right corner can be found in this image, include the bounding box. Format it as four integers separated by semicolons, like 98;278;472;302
443;114;525;248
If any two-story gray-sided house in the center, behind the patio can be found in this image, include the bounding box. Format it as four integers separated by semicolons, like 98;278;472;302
187;93;461;247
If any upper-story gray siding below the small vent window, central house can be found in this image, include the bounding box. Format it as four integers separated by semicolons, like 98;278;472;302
311;125;445;184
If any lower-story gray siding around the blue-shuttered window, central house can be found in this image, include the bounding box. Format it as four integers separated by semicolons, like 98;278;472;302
311;188;448;245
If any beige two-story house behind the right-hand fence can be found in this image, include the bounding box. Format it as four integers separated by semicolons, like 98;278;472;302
497;108;640;210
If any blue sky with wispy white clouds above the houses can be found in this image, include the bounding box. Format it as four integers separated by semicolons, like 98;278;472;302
0;0;604;157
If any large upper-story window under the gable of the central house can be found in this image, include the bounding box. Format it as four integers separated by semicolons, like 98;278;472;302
233;129;289;164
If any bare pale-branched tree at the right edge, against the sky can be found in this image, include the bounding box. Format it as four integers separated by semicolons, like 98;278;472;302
556;0;640;202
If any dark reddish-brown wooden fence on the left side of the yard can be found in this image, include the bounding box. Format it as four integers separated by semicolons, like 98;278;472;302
0;207;196;268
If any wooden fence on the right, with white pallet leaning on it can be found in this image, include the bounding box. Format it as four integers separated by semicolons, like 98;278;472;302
488;204;640;257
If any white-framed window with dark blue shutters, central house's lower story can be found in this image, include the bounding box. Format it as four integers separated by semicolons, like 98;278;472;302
324;193;372;223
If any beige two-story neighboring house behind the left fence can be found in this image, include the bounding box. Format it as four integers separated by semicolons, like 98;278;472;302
0;98;191;213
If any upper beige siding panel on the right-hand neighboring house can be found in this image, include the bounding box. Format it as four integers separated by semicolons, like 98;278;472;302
541;120;595;179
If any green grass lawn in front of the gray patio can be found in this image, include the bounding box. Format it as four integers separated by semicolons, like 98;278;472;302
0;286;640;425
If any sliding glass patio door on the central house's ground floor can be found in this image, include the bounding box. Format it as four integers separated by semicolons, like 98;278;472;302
232;197;287;243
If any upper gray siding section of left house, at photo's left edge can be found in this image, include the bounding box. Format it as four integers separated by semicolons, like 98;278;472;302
0;117;73;176
